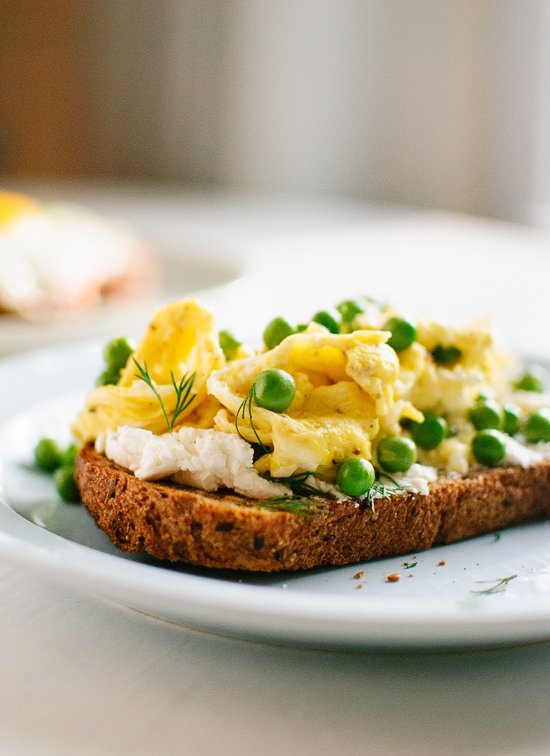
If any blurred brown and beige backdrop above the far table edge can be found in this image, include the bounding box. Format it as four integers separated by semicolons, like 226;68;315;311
0;0;550;224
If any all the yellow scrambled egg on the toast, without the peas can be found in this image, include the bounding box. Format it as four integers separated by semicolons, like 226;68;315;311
72;300;508;479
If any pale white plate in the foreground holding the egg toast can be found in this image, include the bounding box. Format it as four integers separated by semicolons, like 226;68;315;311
0;336;550;648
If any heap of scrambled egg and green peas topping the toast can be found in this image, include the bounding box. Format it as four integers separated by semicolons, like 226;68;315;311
72;299;550;497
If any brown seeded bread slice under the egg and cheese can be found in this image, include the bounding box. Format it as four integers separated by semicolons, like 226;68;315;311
76;445;550;572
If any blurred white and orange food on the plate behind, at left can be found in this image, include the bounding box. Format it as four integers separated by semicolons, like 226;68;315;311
0;190;158;320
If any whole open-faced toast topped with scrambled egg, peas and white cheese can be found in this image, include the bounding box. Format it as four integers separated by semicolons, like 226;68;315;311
68;299;550;571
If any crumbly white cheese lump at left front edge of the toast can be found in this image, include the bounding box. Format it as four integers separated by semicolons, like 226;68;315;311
96;425;291;499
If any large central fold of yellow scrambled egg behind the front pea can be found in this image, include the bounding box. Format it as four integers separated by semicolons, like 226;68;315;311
208;327;422;477
